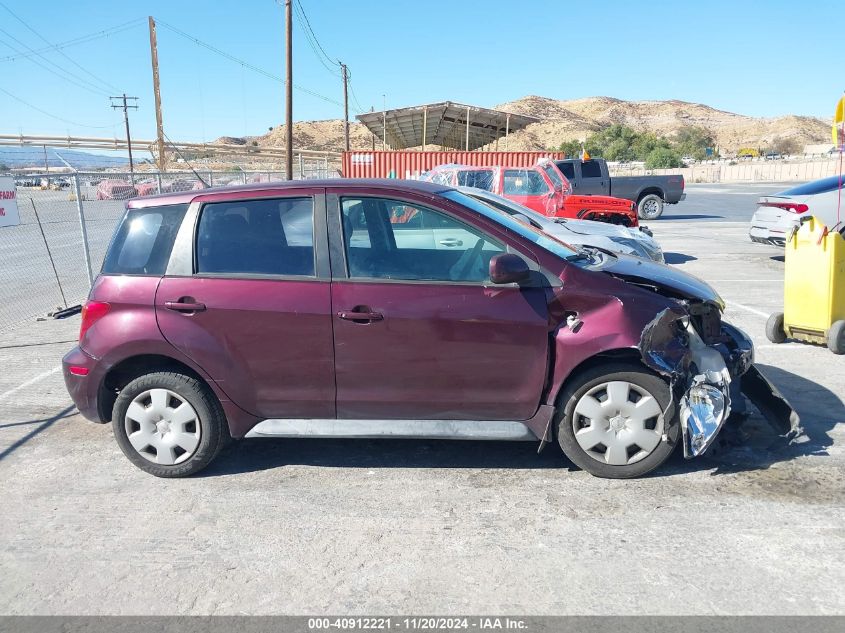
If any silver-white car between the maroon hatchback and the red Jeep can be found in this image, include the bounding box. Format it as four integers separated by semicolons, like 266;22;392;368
458;187;664;264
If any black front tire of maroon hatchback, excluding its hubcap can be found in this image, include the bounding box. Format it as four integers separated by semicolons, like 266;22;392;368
555;362;681;479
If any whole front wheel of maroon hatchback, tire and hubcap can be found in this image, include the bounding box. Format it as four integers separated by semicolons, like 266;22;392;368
556;363;681;479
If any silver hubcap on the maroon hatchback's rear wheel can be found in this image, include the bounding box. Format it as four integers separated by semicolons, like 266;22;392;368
124;389;201;466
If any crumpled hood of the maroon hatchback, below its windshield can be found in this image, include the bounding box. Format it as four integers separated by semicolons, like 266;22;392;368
596;254;725;310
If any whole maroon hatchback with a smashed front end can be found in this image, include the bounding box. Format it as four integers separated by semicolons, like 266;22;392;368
64;179;798;477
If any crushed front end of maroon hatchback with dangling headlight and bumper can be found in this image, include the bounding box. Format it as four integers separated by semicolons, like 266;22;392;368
639;307;801;459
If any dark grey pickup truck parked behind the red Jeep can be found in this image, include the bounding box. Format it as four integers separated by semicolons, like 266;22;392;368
555;158;686;220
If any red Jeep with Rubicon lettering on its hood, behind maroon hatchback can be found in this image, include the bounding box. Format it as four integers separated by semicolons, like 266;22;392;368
424;161;639;226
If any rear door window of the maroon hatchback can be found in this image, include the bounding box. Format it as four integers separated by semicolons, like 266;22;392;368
196;198;314;277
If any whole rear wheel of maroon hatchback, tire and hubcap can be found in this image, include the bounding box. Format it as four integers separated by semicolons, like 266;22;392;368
112;372;228;477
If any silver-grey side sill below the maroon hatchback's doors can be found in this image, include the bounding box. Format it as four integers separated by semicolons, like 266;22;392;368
246;418;537;442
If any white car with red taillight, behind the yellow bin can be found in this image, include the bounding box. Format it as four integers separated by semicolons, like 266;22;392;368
748;176;845;246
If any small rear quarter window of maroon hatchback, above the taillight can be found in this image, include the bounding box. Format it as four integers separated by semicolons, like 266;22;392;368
103;204;188;276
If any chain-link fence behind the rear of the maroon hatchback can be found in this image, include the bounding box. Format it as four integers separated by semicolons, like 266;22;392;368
0;159;339;331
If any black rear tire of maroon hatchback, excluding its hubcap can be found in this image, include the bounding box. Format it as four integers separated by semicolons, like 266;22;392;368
112;372;230;477
